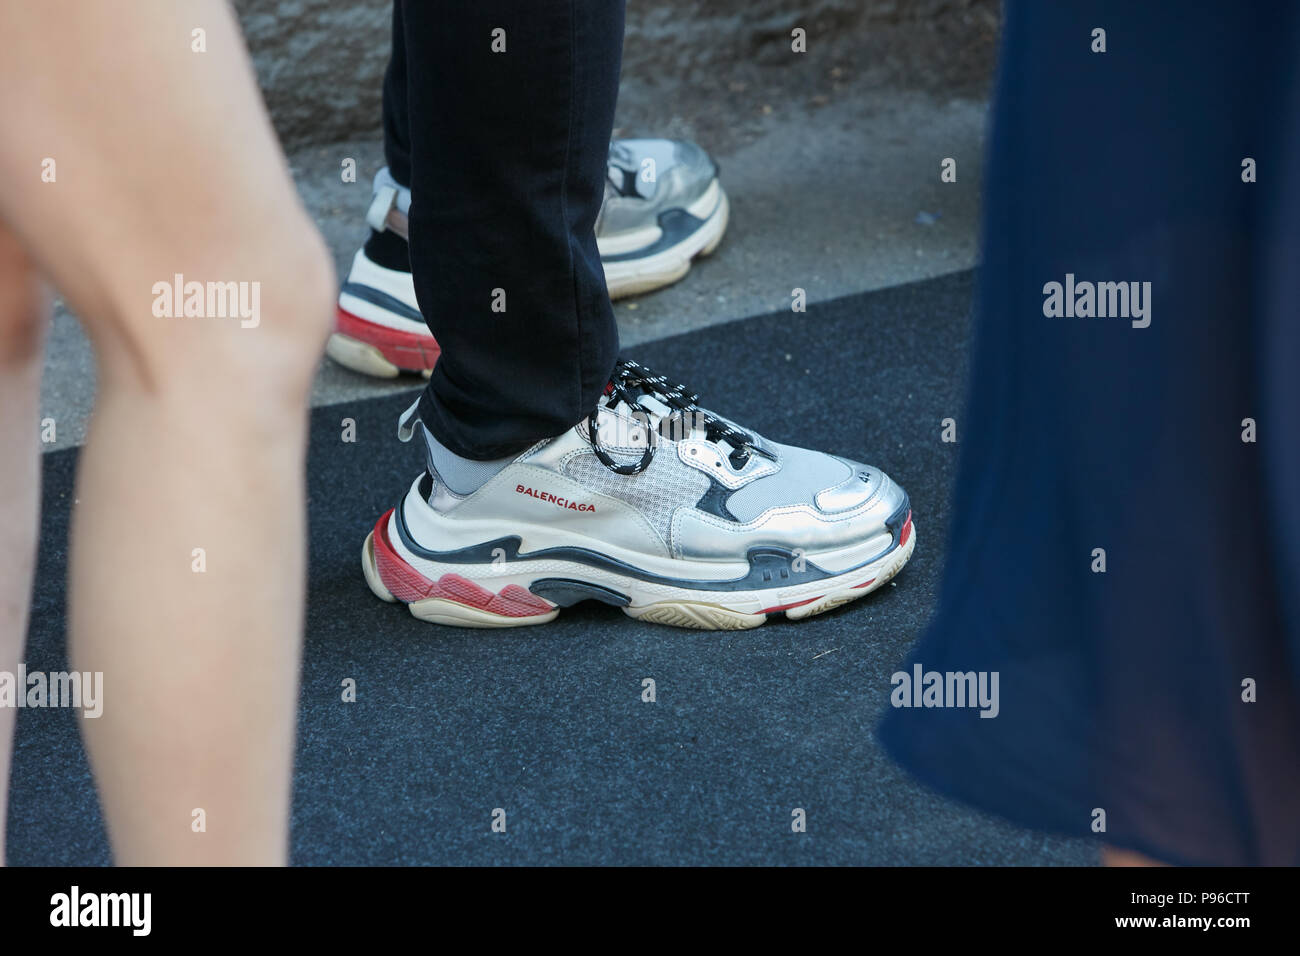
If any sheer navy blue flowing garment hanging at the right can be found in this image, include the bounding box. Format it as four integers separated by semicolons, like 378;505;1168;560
880;0;1300;864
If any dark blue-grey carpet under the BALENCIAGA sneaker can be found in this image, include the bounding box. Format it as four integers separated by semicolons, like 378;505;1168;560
9;273;1093;865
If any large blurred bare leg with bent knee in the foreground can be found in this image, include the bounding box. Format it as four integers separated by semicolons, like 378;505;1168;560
0;0;334;864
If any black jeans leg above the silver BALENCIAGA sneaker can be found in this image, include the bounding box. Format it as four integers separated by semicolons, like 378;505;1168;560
384;0;624;459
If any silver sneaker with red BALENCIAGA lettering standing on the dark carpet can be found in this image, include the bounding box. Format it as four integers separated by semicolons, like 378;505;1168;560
361;360;917;630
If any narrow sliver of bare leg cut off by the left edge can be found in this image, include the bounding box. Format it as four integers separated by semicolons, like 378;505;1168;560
0;222;48;866
